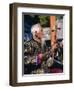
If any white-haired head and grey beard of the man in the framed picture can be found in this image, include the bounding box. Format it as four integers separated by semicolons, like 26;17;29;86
31;23;45;50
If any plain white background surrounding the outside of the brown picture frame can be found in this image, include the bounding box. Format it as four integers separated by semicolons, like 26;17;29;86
0;0;74;90
